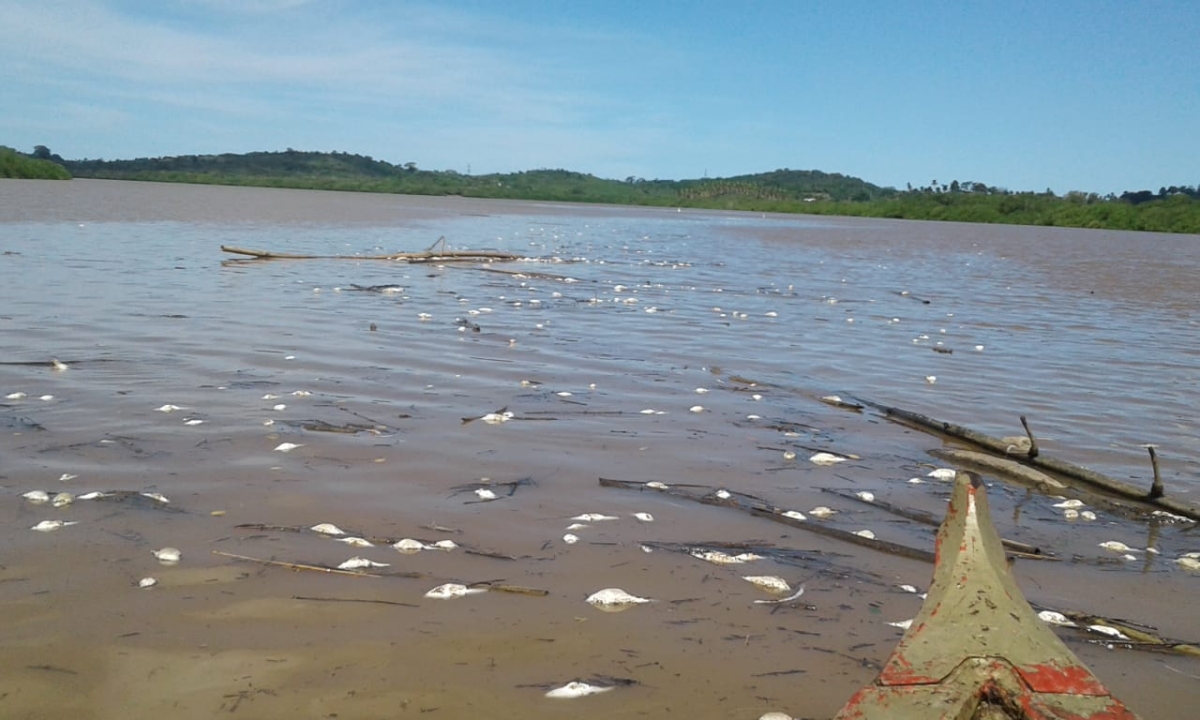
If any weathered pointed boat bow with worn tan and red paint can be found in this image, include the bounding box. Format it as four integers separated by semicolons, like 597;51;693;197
835;473;1139;720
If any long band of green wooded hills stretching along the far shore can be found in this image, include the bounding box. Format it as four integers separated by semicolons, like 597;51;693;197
9;145;1200;234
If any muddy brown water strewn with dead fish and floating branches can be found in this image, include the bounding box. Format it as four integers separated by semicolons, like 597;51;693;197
0;175;1200;720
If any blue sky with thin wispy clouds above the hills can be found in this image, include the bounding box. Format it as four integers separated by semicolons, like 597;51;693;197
0;0;1200;193
